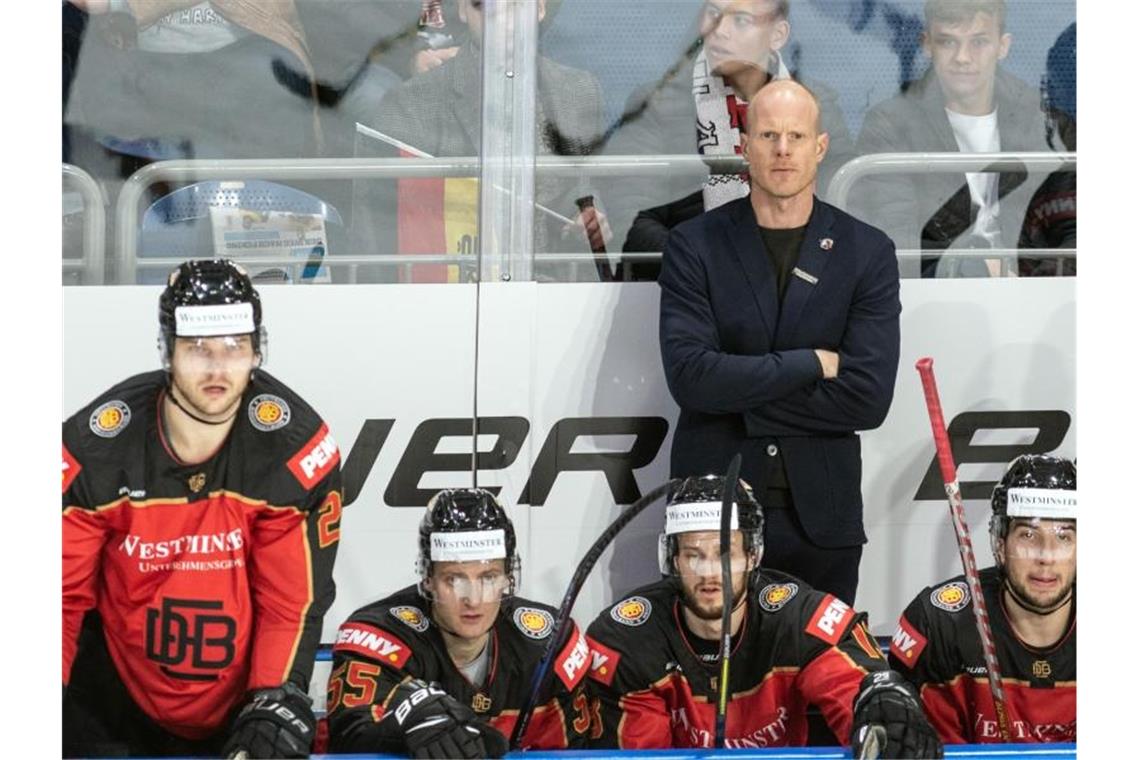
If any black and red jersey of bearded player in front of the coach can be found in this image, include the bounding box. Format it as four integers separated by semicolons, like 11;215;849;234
588;570;887;750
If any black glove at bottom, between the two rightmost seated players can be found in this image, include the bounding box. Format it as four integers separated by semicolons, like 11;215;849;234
850;670;943;758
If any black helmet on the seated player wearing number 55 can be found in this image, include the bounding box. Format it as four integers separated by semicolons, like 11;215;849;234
416;488;522;599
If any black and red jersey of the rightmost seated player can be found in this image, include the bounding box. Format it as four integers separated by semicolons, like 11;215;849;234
889;567;1076;744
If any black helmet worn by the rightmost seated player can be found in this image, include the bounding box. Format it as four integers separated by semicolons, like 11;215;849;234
990;453;1076;558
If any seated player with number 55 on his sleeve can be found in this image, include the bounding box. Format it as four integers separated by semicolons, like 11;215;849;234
327;489;589;758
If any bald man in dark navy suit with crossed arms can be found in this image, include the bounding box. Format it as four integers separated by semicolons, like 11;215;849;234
658;80;902;604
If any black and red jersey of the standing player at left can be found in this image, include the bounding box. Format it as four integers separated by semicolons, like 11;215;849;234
63;369;341;739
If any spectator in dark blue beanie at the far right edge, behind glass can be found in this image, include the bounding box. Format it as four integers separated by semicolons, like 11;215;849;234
1018;22;1076;277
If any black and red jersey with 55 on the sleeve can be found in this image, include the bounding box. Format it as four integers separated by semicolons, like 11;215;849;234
327;586;589;754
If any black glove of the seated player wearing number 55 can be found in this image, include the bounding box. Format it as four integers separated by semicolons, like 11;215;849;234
384;679;508;760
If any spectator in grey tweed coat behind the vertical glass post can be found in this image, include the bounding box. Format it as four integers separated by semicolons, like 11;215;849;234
352;0;612;279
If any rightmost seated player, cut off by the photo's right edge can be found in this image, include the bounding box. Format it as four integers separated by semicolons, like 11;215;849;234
889;455;1076;744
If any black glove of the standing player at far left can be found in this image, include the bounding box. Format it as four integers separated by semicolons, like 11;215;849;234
221;684;317;758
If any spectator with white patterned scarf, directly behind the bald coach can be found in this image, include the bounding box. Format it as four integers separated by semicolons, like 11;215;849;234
605;0;853;279
